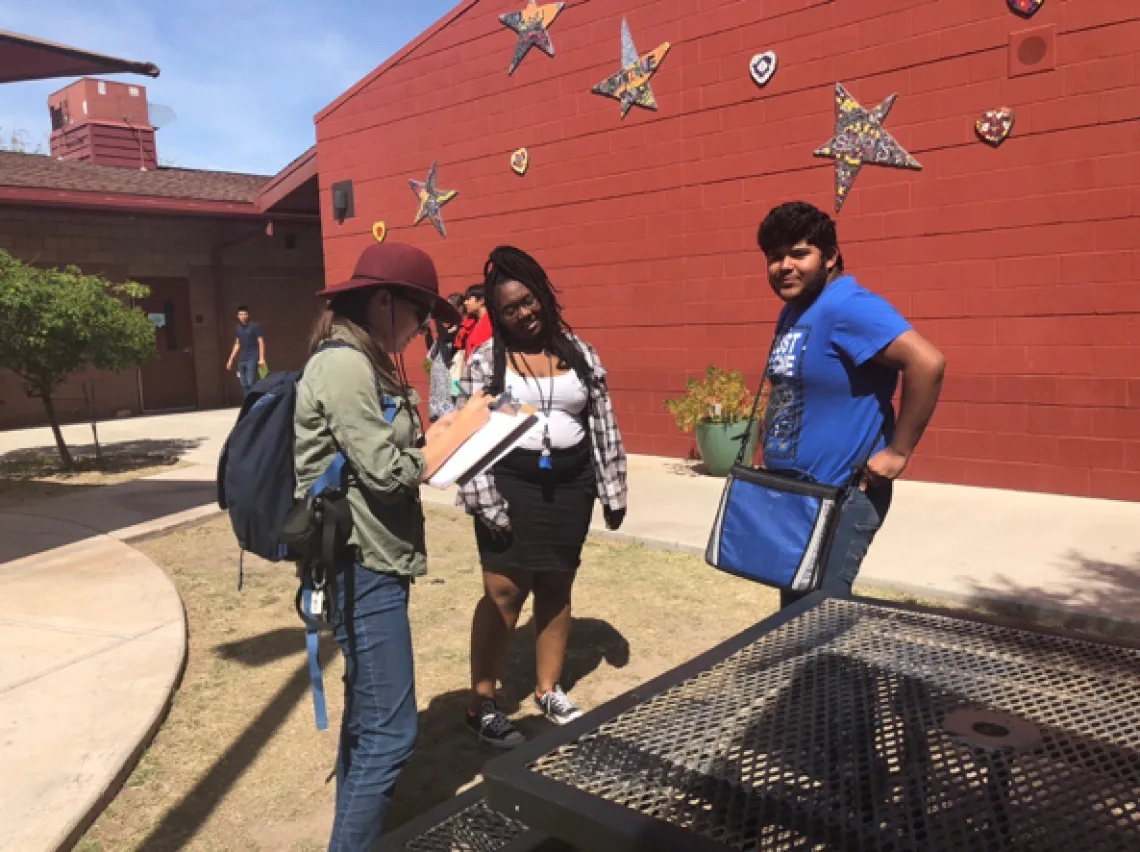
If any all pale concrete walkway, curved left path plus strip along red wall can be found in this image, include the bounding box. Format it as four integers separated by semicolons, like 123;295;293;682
0;411;1140;852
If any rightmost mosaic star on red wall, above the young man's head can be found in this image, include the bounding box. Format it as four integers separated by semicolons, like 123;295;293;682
815;83;922;213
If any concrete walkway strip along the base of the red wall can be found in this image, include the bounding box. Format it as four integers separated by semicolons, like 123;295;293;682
424;456;1140;636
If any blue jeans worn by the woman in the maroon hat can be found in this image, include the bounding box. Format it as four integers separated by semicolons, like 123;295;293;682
328;566;417;852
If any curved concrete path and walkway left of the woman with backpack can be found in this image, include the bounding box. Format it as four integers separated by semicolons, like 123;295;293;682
0;413;233;852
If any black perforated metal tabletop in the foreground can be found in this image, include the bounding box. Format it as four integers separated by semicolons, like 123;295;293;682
486;594;1140;852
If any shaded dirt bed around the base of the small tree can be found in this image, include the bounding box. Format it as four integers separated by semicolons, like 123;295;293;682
0;441;197;509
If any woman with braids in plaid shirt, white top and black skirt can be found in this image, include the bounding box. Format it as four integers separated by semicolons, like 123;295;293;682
459;246;628;748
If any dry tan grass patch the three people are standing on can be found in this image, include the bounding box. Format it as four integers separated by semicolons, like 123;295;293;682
78;510;777;852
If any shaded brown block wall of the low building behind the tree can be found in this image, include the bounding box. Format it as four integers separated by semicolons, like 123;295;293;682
0;205;324;429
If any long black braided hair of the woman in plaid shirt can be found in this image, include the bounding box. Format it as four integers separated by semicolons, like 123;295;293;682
483;245;595;395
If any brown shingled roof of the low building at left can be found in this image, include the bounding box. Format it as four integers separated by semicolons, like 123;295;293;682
0;152;270;204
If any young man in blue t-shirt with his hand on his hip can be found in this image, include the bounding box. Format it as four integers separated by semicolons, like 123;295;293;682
758;202;946;606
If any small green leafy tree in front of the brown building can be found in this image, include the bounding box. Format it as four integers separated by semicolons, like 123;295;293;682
0;249;157;470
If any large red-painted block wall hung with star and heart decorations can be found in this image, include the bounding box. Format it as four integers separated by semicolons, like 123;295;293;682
317;0;1140;500
